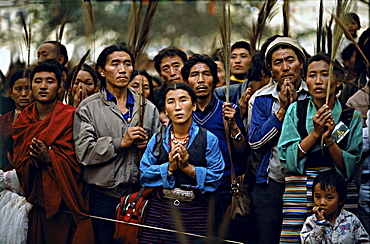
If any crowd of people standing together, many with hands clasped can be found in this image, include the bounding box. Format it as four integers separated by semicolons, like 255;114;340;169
0;10;370;243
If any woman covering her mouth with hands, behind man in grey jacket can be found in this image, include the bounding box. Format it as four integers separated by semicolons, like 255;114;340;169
66;64;99;107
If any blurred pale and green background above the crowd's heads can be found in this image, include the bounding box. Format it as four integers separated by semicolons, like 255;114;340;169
0;0;369;72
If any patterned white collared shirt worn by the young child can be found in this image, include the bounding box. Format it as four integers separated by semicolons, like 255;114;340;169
300;209;370;244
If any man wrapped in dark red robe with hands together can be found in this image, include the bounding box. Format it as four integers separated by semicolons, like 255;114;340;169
13;63;94;243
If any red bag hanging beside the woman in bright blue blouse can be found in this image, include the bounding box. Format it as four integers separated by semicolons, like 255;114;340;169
114;187;153;244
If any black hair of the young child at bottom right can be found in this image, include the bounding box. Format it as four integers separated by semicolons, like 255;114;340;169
312;169;347;202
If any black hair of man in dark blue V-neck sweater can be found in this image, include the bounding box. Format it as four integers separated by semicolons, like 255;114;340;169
181;54;219;85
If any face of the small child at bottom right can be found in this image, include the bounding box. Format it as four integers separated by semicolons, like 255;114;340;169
314;183;343;220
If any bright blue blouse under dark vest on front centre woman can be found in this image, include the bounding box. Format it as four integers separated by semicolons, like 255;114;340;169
140;122;225;193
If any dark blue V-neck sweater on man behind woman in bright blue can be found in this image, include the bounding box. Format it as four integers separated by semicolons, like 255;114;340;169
193;96;246;176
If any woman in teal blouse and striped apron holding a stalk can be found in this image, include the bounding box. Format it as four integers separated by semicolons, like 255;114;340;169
278;53;362;243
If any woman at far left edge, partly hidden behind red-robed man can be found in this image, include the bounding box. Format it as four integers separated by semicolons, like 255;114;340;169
0;70;32;171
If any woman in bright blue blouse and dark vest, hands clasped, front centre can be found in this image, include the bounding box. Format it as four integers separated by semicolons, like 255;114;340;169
140;83;224;243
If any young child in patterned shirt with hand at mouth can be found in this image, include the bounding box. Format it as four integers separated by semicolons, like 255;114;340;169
301;170;370;244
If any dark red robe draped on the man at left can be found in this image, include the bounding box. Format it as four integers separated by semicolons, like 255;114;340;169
13;102;94;243
